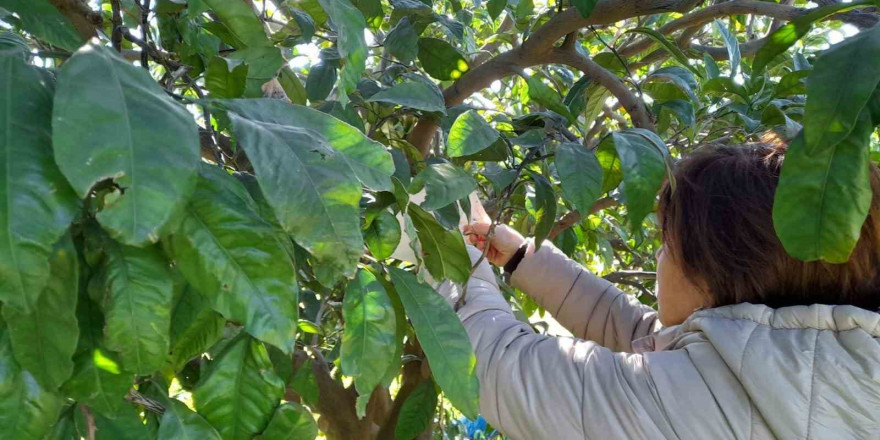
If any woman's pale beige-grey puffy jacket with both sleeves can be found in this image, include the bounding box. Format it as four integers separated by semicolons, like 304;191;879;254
439;243;880;440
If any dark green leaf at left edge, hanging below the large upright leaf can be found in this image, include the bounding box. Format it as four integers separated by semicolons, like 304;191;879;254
3;234;79;391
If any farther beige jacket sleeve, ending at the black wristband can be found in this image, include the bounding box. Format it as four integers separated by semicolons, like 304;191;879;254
511;241;660;352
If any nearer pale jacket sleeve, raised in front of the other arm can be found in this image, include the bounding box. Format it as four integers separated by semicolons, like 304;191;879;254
438;248;675;440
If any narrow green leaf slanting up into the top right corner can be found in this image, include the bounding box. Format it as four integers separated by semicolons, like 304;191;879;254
752;1;874;75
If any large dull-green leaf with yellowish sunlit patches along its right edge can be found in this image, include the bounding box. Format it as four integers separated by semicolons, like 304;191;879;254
226;100;384;276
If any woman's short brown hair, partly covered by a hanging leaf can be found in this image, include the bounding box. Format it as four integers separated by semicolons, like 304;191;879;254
658;143;880;310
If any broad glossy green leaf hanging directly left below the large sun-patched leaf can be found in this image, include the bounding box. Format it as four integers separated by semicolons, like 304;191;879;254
164;165;299;354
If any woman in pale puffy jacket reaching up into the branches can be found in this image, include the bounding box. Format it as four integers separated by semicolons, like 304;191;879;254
440;145;880;440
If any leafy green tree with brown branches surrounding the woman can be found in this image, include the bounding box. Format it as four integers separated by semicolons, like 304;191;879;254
0;0;880;440
